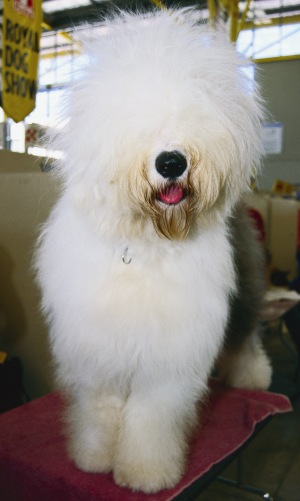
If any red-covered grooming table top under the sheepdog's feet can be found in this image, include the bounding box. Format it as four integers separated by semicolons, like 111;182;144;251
0;380;291;501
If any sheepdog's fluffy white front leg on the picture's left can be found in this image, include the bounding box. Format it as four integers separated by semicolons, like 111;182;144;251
67;391;123;473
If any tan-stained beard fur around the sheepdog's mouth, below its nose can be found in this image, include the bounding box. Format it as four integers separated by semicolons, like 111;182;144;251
129;150;225;240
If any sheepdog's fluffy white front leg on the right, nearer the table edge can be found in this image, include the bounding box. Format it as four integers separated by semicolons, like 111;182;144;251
114;382;197;493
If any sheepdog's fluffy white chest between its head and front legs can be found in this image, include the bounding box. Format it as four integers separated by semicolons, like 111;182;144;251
41;202;235;386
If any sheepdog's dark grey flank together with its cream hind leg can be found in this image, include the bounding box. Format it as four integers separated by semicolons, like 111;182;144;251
217;205;272;390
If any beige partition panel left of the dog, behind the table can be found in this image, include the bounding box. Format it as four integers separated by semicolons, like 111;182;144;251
0;150;57;398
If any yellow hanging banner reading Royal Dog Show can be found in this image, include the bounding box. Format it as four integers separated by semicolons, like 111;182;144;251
2;0;42;122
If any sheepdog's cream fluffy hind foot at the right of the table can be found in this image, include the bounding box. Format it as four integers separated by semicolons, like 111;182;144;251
218;330;272;390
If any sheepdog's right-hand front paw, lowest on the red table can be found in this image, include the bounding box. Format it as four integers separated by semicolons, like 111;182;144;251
114;458;184;494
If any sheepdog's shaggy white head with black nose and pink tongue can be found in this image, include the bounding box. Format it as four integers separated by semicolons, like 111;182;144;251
56;12;262;240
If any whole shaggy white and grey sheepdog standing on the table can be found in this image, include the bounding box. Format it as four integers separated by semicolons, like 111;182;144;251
37;10;271;492
